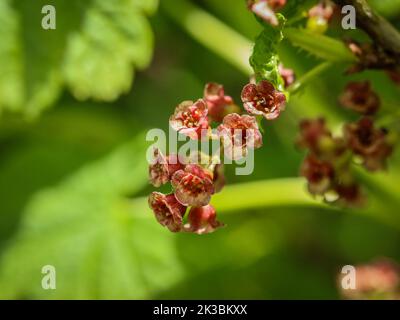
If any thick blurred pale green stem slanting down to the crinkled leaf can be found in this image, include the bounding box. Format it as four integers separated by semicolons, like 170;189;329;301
161;0;253;75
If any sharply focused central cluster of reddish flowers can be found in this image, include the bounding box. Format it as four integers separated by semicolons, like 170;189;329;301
149;81;286;234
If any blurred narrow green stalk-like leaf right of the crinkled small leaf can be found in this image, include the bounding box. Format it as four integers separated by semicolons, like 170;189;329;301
284;28;356;63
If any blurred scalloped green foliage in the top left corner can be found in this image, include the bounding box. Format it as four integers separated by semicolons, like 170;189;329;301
0;0;157;116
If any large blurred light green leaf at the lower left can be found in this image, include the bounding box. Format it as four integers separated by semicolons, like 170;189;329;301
0;135;183;299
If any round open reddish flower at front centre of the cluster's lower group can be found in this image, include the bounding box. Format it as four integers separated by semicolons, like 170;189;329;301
171;164;214;207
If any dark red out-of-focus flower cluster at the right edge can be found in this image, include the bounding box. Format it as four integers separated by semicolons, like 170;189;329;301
297;82;393;205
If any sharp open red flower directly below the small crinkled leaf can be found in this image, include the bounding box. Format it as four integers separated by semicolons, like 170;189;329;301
242;80;286;120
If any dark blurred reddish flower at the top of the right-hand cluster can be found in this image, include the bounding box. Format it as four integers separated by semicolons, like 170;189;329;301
339;81;380;115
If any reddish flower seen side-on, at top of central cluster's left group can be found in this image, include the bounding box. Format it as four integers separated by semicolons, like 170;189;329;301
204;83;239;122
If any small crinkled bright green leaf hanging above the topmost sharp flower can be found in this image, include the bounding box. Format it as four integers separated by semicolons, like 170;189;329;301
250;14;285;91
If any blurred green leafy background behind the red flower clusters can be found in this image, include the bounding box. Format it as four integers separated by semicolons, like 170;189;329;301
0;0;400;299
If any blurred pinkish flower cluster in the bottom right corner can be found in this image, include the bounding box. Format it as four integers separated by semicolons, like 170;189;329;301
338;259;400;300
